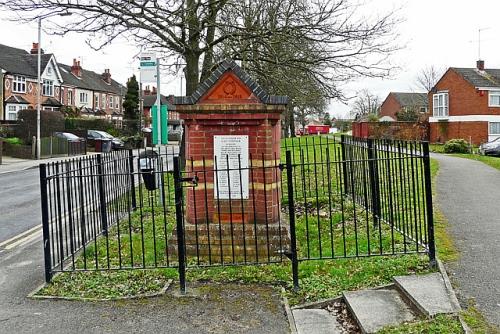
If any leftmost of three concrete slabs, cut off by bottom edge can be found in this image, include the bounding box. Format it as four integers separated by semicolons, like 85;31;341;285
292;309;343;334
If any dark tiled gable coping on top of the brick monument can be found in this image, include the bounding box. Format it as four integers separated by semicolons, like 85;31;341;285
174;59;288;104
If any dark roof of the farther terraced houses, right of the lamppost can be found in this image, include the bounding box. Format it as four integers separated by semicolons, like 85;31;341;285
57;63;127;95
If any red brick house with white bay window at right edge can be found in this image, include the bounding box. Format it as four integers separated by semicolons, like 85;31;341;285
428;60;500;145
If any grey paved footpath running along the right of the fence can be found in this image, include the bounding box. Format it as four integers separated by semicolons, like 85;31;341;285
433;154;500;326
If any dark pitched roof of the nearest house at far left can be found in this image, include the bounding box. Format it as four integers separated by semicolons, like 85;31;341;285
0;44;53;77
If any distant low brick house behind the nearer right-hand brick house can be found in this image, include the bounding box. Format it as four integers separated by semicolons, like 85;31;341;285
380;92;428;121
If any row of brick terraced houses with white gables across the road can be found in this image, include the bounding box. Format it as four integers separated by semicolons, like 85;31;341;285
0;43;126;120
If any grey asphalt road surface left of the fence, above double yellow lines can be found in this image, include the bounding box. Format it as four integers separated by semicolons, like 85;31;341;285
0;168;41;243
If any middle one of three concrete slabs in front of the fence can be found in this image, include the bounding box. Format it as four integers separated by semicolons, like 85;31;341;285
344;289;416;334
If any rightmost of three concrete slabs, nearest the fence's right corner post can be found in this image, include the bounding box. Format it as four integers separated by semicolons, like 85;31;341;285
394;273;455;317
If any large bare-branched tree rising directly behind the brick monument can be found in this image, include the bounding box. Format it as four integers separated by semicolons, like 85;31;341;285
0;0;398;98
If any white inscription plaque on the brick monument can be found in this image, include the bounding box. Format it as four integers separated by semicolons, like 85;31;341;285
214;135;248;199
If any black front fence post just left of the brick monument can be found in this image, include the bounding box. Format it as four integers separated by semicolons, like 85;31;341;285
174;156;186;294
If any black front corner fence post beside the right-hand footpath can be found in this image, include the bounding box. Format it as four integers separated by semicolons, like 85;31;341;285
423;142;436;268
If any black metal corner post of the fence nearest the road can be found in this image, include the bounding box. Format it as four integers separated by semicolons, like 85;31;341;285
39;164;52;283
